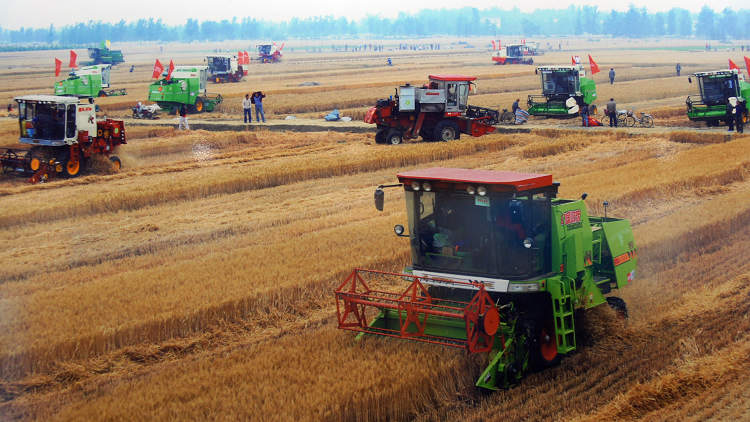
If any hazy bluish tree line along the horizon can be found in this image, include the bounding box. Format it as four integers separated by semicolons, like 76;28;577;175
0;5;750;49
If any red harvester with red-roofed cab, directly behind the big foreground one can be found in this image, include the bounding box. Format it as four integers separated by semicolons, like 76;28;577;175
365;75;500;145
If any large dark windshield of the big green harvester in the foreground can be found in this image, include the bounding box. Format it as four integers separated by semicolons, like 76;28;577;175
406;191;550;279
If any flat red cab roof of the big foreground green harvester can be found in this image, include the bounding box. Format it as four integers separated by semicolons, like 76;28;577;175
396;167;552;191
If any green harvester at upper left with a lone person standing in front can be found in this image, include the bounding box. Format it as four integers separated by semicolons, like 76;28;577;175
148;66;222;113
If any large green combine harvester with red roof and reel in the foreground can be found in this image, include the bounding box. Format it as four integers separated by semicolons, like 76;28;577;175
335;168;637;390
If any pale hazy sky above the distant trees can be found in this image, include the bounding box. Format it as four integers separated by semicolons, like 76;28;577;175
0;0;748;29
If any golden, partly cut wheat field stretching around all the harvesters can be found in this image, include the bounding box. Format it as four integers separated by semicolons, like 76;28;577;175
0;39;750;421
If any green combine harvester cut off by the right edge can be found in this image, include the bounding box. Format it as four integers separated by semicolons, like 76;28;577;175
685;69;750;126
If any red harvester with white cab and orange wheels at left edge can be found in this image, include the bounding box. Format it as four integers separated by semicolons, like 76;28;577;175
0;95;127;183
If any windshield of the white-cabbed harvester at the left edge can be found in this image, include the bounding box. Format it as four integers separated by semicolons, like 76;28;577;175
18;102;65;140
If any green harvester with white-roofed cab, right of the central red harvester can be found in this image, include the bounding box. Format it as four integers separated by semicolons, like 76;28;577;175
528;65;596;118
